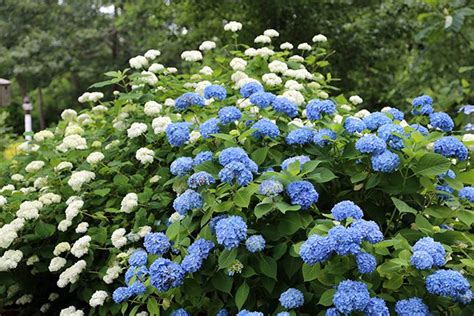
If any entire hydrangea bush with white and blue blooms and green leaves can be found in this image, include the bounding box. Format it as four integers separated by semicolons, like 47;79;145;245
0;22;474;316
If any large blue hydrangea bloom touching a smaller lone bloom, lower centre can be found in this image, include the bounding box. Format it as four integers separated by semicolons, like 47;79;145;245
216;216;247;249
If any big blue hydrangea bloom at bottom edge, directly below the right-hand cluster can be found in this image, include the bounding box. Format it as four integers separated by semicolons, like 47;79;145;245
332;280;370;314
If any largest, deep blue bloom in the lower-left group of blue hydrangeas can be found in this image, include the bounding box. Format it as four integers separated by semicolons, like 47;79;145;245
150;258;185;292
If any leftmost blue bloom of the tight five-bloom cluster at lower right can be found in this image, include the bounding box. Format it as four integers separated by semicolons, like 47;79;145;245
300;235;335;265
